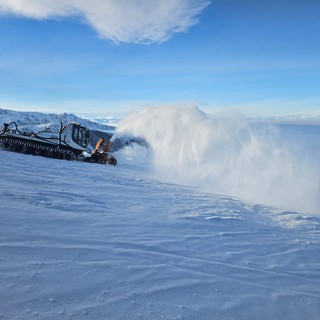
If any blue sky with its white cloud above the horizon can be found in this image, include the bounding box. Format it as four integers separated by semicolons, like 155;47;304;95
0;0;320;115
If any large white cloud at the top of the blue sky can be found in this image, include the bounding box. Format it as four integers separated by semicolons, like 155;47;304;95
0;0;210;43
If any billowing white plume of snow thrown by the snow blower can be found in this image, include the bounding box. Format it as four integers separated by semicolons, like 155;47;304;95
118;107;320;213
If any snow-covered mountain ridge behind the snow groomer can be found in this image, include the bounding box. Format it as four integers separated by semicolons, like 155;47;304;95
0;108;115;132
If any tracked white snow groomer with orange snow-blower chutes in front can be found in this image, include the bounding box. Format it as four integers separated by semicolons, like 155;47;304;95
0;122;117;165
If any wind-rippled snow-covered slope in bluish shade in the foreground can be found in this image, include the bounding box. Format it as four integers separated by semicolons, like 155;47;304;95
0;151;320;320
